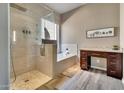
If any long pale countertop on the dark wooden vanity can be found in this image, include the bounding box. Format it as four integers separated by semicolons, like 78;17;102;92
80;48;123;53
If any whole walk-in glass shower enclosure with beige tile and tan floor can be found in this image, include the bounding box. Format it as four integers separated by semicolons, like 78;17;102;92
10;4;56;89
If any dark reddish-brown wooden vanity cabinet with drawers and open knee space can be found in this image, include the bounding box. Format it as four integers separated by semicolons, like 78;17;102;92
80;50;123;79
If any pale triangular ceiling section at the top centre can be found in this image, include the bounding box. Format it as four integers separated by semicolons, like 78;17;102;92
46;3;85;14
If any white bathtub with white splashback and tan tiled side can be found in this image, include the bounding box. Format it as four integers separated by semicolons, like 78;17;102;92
55;44;78;74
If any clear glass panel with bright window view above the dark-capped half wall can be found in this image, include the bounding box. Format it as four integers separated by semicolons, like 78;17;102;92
41;12;57;40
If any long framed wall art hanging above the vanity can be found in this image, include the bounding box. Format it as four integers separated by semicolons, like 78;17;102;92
86;27;114;38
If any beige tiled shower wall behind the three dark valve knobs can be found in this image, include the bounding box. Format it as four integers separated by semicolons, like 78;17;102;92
11;4;50;76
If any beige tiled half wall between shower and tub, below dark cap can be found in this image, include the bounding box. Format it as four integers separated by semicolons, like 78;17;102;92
35;44;57;78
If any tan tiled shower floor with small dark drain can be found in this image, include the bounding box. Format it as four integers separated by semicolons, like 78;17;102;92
10;70;52;90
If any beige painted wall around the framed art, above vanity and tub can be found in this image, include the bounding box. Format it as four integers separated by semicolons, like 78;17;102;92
61;4;120;48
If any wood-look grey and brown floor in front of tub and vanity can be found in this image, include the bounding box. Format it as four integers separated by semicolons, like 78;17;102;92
38;65;124;90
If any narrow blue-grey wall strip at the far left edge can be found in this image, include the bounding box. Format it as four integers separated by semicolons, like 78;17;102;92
0;3;10;90
